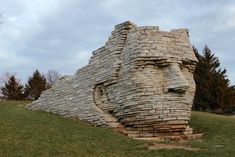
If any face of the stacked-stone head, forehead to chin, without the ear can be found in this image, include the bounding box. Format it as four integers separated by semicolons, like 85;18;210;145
110;29;196;130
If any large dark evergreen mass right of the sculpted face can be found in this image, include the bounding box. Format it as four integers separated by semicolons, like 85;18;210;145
193;45;234;112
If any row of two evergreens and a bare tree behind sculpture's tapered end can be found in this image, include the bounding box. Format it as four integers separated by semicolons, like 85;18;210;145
1;70;60;100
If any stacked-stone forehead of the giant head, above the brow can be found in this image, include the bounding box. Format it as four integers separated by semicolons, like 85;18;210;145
125;27;197;62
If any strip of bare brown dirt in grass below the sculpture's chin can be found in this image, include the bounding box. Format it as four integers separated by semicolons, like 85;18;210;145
149;143;201;151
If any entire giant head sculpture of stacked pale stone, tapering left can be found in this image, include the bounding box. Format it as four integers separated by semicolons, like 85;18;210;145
27;21;197;137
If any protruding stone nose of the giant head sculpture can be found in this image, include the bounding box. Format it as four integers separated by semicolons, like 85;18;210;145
164;63;189;93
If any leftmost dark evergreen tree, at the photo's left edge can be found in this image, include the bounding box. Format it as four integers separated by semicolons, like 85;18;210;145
1;75;24;100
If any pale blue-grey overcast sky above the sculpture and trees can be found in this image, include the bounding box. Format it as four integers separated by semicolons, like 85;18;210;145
0;0;235;84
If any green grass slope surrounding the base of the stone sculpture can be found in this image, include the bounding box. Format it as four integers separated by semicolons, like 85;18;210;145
0;101;235;157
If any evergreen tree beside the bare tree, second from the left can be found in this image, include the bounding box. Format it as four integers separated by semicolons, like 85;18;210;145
25;70;47;100
